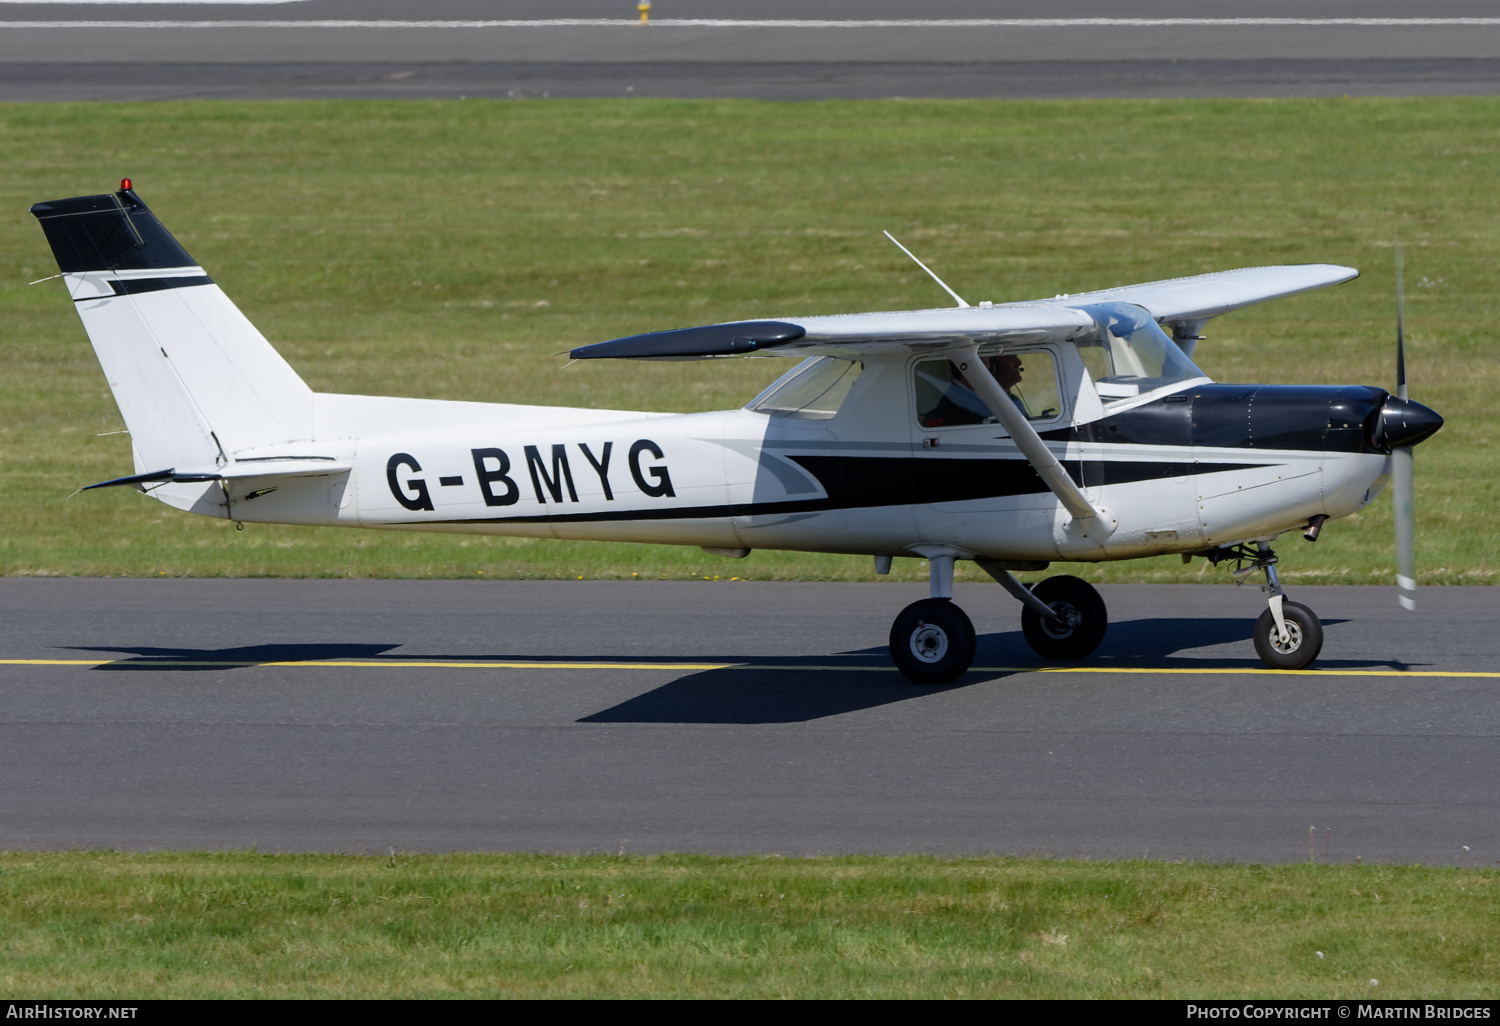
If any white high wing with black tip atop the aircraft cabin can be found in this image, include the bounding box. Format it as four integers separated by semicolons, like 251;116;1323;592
570;264;1359;360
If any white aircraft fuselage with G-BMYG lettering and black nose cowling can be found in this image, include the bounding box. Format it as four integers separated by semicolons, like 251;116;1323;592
156;353;1389;561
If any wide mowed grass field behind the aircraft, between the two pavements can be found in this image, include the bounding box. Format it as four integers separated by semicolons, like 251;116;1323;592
0;98;1500;584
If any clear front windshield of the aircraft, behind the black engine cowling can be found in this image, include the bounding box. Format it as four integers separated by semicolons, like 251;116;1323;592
1077;303;1205;402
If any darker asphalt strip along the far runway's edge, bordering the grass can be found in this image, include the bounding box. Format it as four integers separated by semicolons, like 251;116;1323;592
14;59;1500;102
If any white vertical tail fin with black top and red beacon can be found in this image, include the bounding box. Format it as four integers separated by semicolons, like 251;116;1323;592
32;182;312;473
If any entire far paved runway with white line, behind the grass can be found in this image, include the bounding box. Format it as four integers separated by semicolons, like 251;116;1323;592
0;0;1500;101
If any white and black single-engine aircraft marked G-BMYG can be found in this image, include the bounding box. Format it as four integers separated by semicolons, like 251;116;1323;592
32;180;1443;684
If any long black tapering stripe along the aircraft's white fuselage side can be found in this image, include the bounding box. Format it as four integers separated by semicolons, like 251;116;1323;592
428;456;1263;524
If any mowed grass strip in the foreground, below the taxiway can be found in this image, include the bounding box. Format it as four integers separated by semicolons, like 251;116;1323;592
0;852;1500;999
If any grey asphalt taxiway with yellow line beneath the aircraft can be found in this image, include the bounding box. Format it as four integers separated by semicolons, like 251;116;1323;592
0;567;1500;864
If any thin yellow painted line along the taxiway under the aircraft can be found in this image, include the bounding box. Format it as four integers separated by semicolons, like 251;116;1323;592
0;656;1500;678
